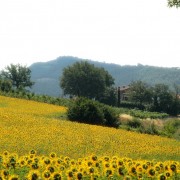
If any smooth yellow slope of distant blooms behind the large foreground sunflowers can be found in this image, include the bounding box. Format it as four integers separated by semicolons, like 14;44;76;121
0;96;180;179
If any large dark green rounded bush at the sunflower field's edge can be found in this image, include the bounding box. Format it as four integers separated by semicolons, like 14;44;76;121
67;98;118;127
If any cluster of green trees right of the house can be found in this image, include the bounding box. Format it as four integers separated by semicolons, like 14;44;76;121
129;81;180;115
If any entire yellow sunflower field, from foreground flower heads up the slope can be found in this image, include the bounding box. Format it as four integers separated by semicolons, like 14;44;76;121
0;96;180;180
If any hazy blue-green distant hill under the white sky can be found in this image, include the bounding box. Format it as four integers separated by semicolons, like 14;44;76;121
29;56;180;96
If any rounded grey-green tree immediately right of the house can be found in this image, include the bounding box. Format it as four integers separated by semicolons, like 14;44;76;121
129;81;152;105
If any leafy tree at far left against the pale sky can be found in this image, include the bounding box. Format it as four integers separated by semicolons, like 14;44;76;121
1;64;34;90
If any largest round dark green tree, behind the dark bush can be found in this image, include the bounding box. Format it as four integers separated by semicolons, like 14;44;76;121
60;61;114;100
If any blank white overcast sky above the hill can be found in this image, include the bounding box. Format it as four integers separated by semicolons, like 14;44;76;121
0;0;180;69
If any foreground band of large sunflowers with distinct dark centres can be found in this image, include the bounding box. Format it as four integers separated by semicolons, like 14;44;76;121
0;150;180;180
